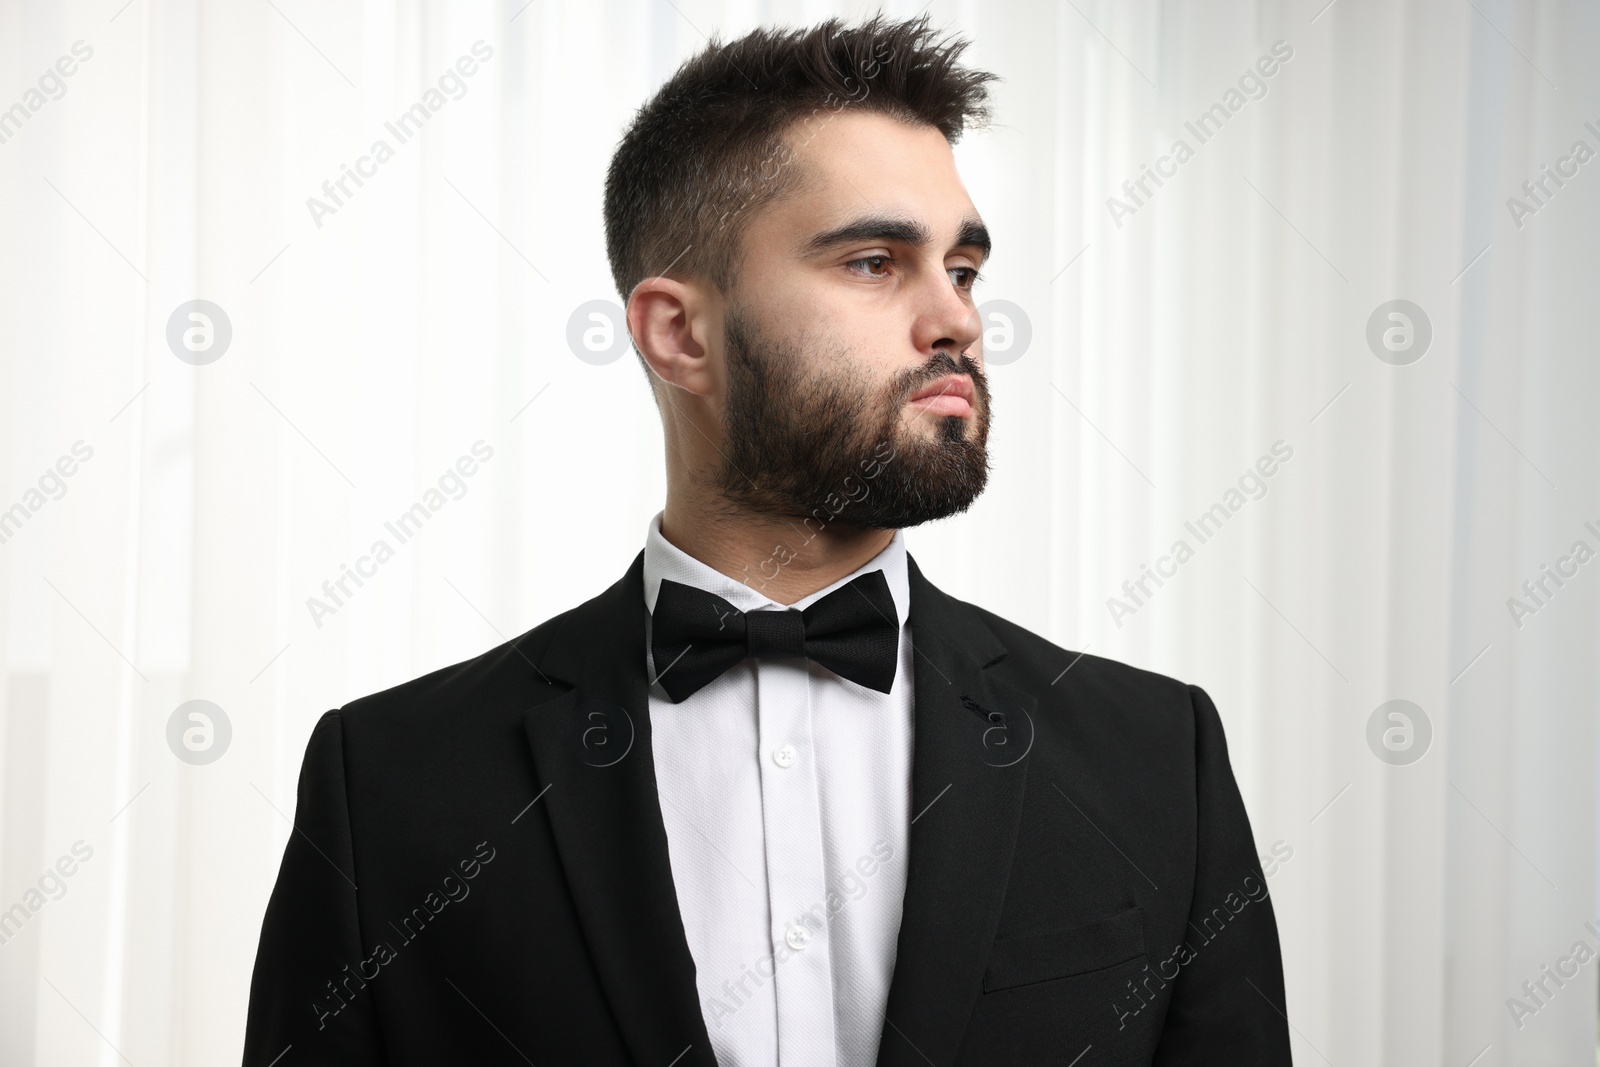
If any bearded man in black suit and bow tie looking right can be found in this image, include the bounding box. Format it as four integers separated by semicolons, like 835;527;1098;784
245;19;1290;1067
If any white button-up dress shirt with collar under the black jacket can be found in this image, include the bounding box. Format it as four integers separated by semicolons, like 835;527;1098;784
645;514;914;1067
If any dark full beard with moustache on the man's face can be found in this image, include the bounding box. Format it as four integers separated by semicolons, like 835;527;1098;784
715;303;989;530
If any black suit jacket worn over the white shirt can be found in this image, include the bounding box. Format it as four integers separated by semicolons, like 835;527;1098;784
245;553;1290;1067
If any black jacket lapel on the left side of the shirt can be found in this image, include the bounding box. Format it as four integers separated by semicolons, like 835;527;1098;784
523;553;717;1067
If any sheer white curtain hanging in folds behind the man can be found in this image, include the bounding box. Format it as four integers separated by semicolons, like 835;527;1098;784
0;0;1600;1067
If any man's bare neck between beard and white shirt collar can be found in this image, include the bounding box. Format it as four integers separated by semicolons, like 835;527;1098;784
661;494;894;605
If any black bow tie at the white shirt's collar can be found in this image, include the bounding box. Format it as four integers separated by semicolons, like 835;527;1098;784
650;571;899;704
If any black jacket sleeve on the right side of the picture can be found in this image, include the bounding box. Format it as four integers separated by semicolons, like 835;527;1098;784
1154;686;1291;1067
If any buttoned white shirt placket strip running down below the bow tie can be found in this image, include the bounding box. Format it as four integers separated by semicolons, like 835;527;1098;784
757;661;837;1067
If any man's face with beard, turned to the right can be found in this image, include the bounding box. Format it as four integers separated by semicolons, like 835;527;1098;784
718;110;989;530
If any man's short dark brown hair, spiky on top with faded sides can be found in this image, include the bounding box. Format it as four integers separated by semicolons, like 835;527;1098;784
605;14;995;301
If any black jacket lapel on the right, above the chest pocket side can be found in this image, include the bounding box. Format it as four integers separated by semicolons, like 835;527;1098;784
877;560;1037;1067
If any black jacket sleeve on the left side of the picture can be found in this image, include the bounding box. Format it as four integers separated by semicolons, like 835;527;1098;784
245;712;386;1067
